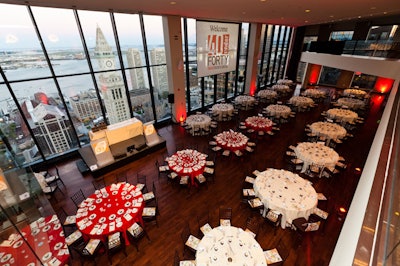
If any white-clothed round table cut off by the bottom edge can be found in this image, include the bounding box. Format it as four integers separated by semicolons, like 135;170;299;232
196;226;267;266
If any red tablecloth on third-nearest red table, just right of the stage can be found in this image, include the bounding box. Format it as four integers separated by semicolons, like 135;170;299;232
166;149;207;185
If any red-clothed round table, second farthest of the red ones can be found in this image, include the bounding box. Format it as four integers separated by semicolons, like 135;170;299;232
214;130;249;152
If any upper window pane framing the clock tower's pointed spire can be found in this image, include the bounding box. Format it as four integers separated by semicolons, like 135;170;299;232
78;10;120;71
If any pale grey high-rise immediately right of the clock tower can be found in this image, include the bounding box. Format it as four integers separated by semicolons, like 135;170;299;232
126;48;146;90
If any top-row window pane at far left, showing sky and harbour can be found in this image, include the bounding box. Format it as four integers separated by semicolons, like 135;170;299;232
0;4;51;81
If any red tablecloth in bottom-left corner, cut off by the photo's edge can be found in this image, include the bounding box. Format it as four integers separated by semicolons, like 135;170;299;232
0;215;69;266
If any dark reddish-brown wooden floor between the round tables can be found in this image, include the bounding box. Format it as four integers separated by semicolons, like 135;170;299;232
44;86;383;266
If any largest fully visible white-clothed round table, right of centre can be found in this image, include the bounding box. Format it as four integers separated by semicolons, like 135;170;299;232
253;168;318;229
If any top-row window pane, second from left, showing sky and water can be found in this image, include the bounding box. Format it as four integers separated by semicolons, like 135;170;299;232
32;7;89;75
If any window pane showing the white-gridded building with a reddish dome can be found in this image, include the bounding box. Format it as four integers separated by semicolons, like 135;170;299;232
11;79;77;156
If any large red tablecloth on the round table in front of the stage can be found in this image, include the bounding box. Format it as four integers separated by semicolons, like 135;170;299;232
76;183;144;244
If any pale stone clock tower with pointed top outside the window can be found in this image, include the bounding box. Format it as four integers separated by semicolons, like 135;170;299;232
94;26;131;124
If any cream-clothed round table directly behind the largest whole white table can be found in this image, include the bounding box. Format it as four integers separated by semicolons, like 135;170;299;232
294;142;339;173
